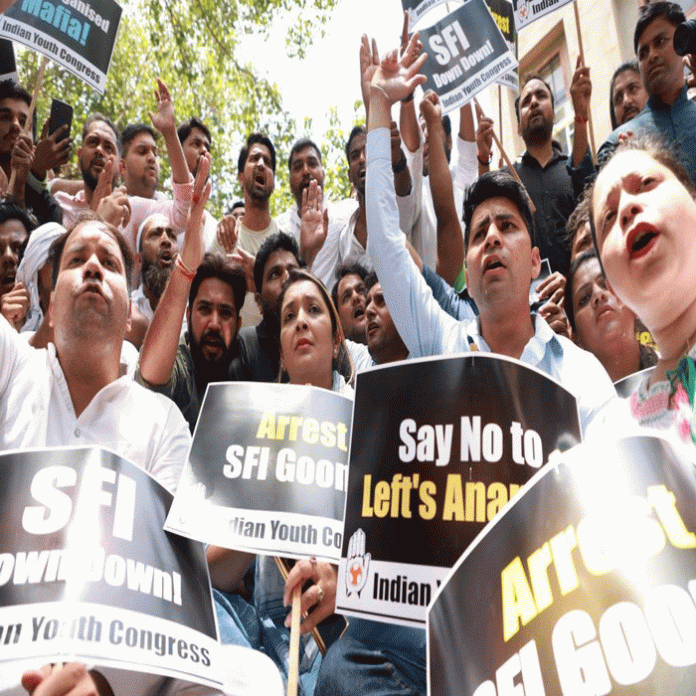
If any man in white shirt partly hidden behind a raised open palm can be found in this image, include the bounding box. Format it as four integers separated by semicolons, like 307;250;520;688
276;138;358;288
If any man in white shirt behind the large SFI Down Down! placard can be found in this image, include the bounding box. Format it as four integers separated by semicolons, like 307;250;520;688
0;219;190;492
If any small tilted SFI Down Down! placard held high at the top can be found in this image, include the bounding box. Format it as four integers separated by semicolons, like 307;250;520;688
420;0;517;112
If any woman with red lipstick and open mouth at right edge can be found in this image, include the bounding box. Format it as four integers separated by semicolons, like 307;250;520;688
591;137;696;443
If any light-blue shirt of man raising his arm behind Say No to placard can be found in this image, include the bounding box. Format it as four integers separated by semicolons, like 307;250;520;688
365;128;616;432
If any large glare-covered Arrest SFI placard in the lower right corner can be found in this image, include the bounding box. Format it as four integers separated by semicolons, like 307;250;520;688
428;435;696;696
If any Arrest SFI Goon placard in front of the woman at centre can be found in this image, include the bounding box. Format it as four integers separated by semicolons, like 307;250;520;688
166;382;352;560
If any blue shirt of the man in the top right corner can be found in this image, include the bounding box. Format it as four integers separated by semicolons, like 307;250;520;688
597;87;696;184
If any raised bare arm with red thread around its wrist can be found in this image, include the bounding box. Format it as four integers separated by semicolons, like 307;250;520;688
139;154;210;385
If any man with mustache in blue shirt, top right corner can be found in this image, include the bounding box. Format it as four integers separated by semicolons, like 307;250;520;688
597;2;696;184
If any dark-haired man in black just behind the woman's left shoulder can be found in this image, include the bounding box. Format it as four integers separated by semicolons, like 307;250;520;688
230;232;302;382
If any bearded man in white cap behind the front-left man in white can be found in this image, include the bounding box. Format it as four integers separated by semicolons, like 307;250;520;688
131;213;179;321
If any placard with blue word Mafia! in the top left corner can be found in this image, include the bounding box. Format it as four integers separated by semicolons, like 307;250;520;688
0;0;121;94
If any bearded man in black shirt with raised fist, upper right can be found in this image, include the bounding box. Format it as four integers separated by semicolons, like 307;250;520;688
476;67;594;276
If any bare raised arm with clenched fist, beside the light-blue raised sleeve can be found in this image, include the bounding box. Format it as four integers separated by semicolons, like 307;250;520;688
421;90;464;285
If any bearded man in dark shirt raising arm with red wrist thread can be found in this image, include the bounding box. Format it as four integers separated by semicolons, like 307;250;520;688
135;154;246;432
